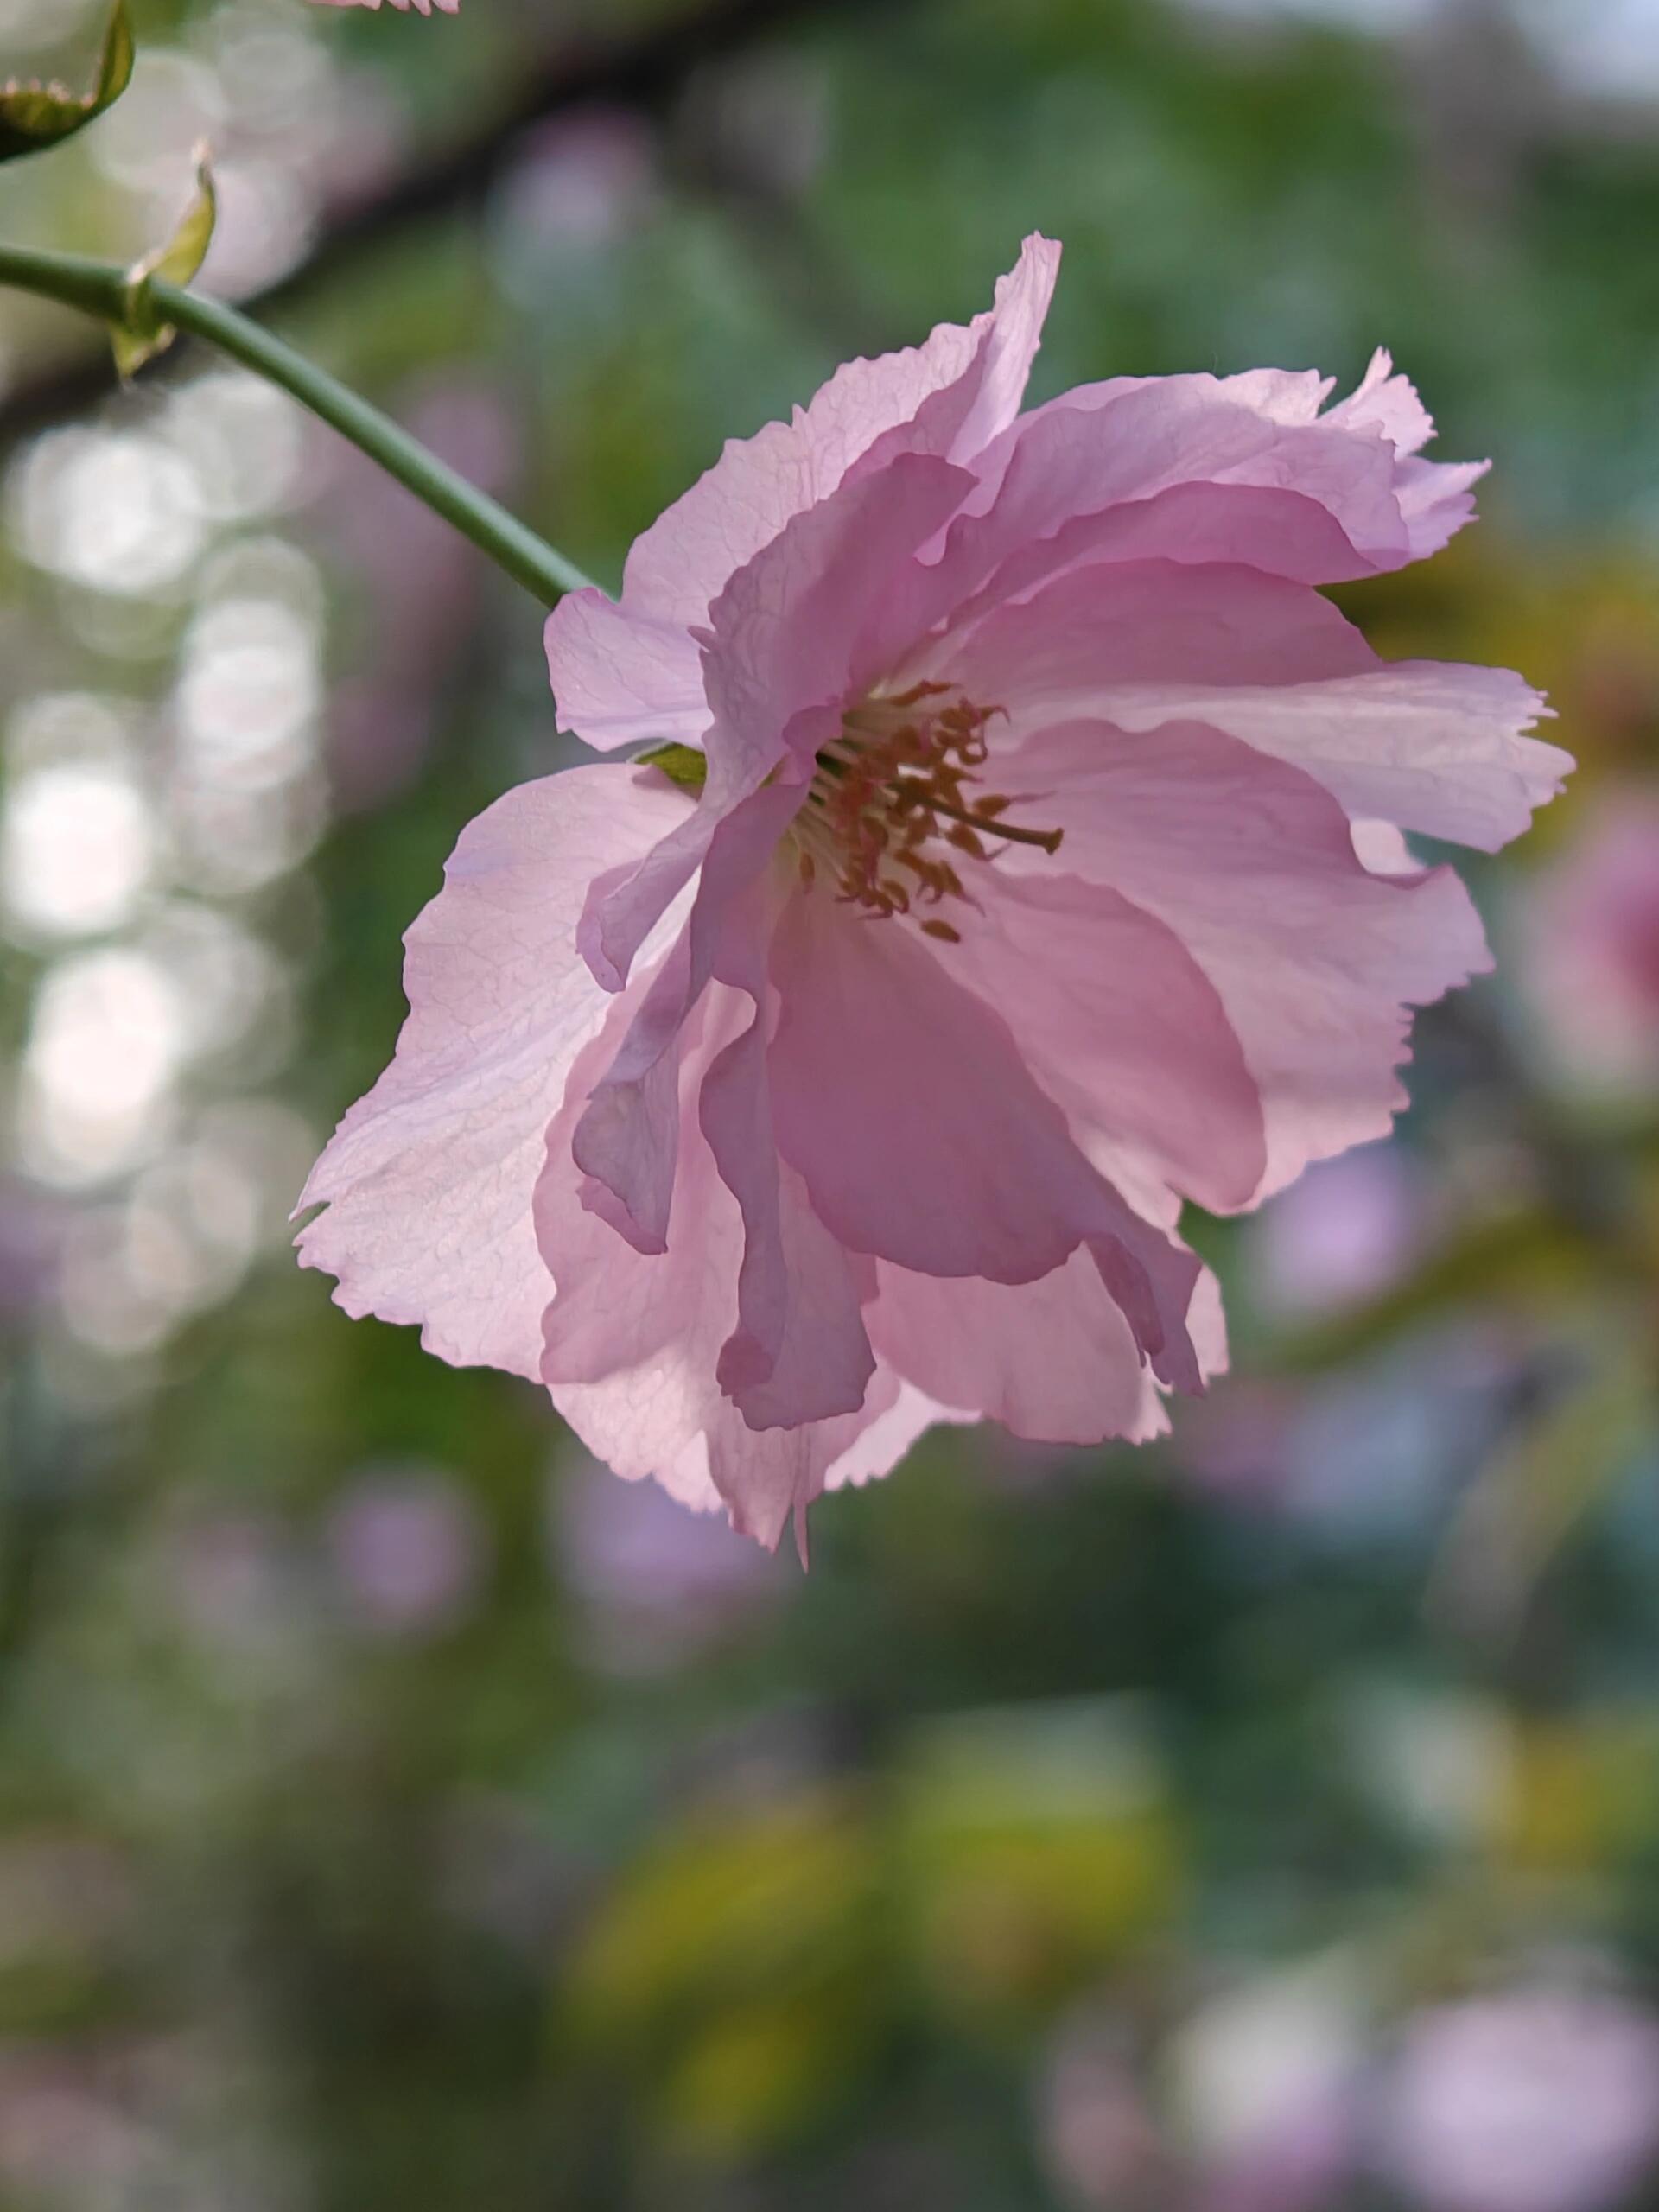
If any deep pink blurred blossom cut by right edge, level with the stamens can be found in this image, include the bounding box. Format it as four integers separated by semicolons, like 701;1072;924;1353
1520;791;1659;1093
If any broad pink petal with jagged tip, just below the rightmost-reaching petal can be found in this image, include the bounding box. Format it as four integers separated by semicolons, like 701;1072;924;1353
1004;723;1491;1197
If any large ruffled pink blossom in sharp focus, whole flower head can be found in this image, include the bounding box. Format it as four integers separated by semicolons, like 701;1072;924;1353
301;238;1571;1544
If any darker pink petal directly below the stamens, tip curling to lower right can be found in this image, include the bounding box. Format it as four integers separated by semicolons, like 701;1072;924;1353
770;896;1197;1387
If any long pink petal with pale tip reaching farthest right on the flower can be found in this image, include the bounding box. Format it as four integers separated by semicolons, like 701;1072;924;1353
938;562;1573;852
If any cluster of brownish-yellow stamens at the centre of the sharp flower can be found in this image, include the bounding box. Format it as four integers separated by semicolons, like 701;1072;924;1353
790;683;1062;944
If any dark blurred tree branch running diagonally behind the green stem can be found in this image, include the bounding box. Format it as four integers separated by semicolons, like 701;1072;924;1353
0;0;898;449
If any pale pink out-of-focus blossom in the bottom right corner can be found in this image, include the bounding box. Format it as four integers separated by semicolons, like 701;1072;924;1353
1378;1988;1659;2212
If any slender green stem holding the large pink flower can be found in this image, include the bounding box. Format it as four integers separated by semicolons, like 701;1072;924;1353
0;245;588;606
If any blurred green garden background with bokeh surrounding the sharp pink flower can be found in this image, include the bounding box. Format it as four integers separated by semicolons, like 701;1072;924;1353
0;0;1659;2212
